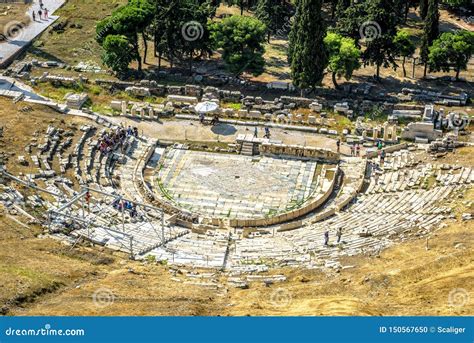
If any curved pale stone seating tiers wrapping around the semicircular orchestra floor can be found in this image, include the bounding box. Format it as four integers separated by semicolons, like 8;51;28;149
0;121;474;273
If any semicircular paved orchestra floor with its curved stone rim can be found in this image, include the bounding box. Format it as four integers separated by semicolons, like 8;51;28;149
146;145;366;228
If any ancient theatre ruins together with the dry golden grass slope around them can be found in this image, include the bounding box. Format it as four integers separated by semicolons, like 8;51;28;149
0;101;474;315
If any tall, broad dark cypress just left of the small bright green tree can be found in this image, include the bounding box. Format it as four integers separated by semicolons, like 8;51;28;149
288;0;328;90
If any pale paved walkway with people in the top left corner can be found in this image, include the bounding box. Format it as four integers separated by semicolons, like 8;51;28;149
0;0;66;68
